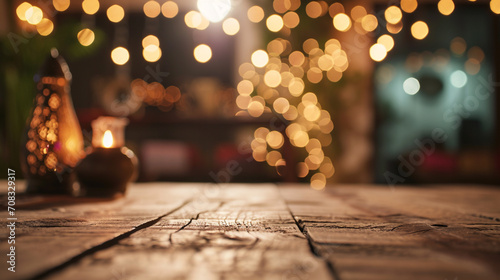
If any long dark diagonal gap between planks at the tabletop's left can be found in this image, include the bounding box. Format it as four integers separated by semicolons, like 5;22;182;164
33;199;191;279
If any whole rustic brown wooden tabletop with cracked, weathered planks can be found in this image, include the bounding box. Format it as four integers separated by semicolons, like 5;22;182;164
0;181;500;280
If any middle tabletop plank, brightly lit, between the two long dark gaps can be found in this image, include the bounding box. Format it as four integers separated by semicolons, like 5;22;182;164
42;185;332;280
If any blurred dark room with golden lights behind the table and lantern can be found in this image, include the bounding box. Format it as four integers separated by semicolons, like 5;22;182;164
0;0;500;189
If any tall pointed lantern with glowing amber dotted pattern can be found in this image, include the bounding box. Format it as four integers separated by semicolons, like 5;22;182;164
21;49;83;194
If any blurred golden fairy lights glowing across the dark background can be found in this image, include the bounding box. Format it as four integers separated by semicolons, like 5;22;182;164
16;0;500;189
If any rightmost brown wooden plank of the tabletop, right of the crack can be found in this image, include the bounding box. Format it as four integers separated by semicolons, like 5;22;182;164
281;184;500;279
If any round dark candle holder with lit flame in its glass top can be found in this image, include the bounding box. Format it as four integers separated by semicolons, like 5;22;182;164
76;117;137;197
